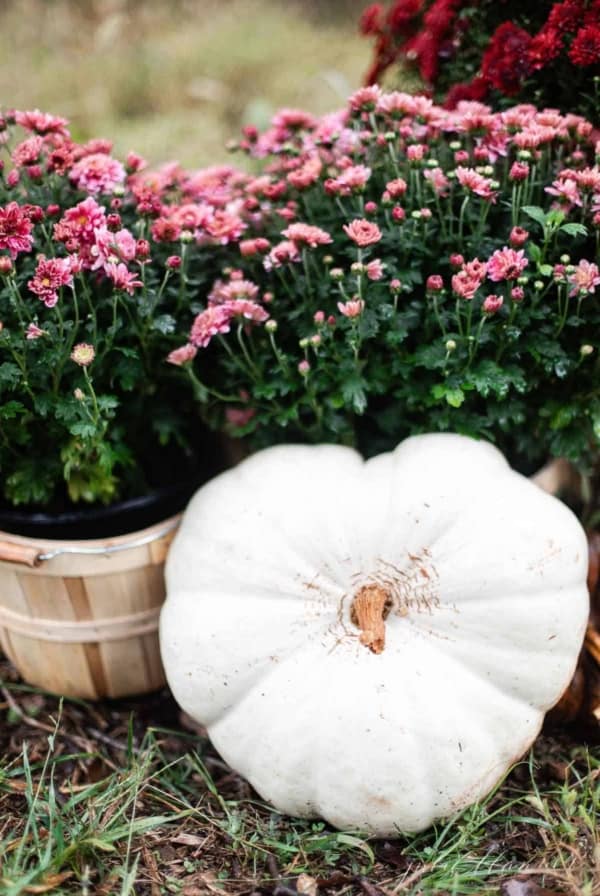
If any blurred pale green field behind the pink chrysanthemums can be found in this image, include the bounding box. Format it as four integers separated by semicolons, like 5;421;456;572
0;0;371;167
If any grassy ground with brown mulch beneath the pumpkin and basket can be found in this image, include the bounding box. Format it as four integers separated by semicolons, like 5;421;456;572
0;664;600;896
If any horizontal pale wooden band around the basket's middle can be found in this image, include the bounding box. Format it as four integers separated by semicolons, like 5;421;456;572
0;606;160;644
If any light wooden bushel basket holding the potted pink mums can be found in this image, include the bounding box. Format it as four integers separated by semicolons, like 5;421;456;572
0;515;181;700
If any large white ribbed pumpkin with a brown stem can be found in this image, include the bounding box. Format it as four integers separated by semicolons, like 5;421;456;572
161;434;588;835
